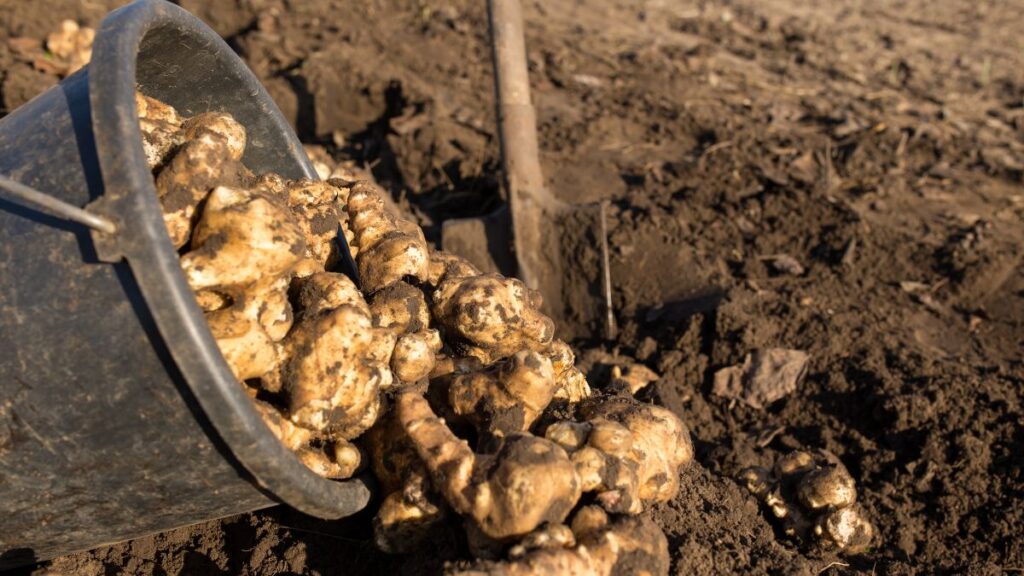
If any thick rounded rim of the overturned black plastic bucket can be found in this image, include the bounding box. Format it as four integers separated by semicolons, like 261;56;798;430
88;0;370;519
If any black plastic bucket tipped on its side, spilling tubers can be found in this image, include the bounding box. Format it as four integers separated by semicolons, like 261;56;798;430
0;0;369;570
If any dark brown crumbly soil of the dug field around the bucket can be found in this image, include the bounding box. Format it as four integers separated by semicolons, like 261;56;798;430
0;0;1024;575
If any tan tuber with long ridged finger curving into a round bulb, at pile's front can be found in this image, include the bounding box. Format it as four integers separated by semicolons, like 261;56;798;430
396;390;580;540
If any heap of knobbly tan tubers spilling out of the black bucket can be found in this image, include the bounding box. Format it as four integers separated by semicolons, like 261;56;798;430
142;94;693;575
